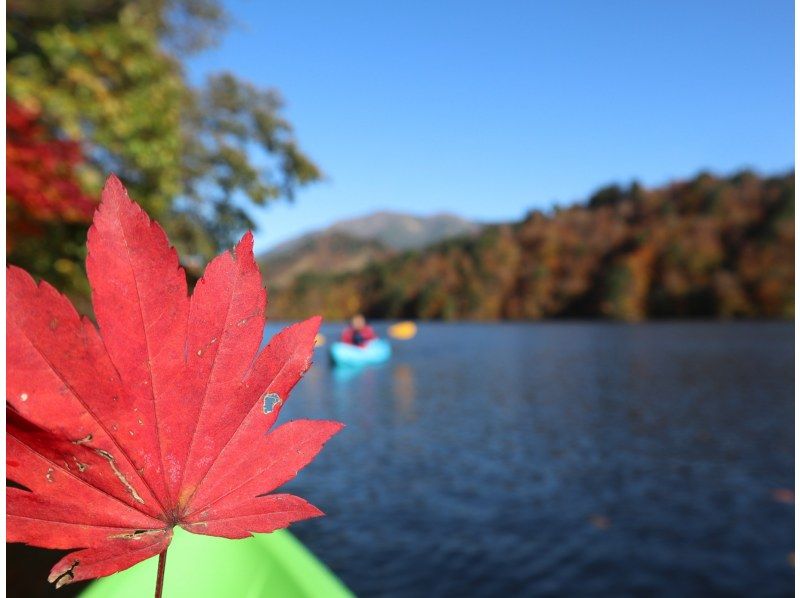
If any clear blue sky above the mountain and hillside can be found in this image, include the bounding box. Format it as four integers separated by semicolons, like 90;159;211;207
189;0;794;249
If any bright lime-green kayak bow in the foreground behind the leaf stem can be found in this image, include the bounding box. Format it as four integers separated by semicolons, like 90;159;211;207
81;527;353;598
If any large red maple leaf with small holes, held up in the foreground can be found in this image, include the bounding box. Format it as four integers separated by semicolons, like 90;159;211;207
7;176;342;586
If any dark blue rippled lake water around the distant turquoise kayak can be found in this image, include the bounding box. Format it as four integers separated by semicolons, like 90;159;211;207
267;322;794;596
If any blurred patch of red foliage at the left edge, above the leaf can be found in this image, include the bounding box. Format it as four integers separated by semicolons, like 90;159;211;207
6;99;96;227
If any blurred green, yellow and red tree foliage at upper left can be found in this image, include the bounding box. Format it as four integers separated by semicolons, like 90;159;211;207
6;0;321;306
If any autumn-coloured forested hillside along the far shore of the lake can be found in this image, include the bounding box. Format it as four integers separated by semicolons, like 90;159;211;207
270;172;794;320
